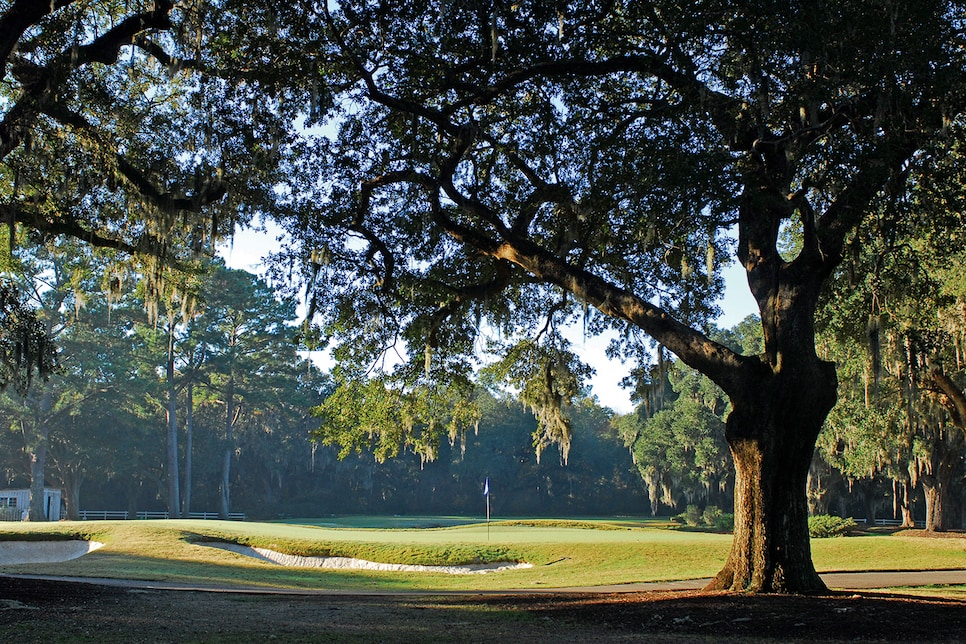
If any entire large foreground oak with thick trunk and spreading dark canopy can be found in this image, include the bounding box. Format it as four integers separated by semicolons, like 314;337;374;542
285;0;966;592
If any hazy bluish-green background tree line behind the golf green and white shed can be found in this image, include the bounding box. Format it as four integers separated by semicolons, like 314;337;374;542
0;243;646;520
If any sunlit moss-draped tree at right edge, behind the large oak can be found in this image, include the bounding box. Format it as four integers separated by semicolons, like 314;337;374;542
819;135;966;530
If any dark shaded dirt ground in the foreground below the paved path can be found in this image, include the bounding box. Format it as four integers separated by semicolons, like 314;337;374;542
0;577;966;642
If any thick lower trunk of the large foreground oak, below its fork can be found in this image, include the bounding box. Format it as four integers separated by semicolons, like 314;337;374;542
708;359;836;593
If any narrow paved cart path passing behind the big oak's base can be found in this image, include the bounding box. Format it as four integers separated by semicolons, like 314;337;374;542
0;570;966;597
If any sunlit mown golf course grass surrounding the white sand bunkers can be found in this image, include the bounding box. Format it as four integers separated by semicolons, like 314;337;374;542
0;520;966;592
